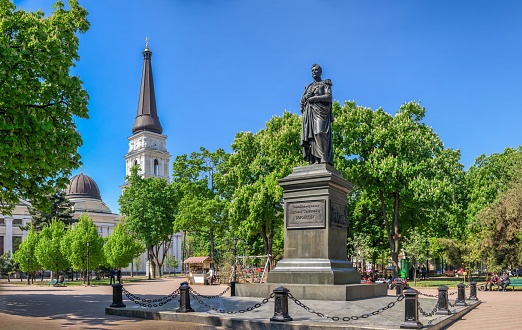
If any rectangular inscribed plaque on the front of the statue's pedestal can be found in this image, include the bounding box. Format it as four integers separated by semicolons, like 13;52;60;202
286;200;326;229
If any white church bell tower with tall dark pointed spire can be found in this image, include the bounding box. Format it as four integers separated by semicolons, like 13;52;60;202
125;38;170;181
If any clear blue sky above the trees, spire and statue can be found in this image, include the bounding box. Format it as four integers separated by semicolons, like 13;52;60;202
15;0;522;213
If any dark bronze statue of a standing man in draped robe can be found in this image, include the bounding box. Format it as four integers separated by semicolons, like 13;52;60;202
301;64;333;165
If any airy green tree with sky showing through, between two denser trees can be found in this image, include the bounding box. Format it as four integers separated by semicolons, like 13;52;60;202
171;148;228;258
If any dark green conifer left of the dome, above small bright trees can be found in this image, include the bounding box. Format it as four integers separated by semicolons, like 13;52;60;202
20;190;76;231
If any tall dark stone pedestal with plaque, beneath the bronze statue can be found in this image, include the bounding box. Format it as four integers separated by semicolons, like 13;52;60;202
267;164;360;285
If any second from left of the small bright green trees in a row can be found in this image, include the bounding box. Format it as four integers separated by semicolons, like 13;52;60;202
35;219;70;279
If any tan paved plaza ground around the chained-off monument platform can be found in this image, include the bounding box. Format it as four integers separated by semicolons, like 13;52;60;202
0;278;522;330
